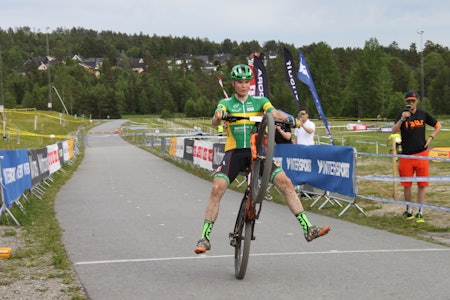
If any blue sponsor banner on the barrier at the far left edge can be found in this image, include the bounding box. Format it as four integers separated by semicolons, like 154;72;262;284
0;149;32;207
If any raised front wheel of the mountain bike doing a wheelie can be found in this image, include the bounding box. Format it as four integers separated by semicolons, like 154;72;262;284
251;113;275;203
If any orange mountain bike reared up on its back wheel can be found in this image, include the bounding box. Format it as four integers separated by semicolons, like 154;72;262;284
229;113;275;279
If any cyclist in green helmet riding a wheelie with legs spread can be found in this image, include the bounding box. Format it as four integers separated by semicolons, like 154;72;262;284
194;64;330;254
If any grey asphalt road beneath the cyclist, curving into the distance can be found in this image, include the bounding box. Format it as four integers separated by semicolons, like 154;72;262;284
55;120;450;300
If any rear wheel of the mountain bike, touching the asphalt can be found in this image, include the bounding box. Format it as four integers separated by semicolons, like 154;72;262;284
234;196;254;279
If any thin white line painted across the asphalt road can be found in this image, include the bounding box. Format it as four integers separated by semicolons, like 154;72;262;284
75;248;450;266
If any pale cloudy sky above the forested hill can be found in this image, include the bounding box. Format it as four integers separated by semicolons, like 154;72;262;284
0;0;450;50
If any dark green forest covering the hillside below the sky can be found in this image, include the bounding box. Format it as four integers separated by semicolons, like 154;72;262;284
0;26;450;119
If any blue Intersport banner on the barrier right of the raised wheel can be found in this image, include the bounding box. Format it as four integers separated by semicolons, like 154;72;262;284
274;144;357;198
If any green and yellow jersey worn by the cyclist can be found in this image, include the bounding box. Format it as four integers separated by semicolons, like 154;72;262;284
216;95;275;151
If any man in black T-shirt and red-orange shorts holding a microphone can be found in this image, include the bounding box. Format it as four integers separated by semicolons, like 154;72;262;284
392;91;441;223
